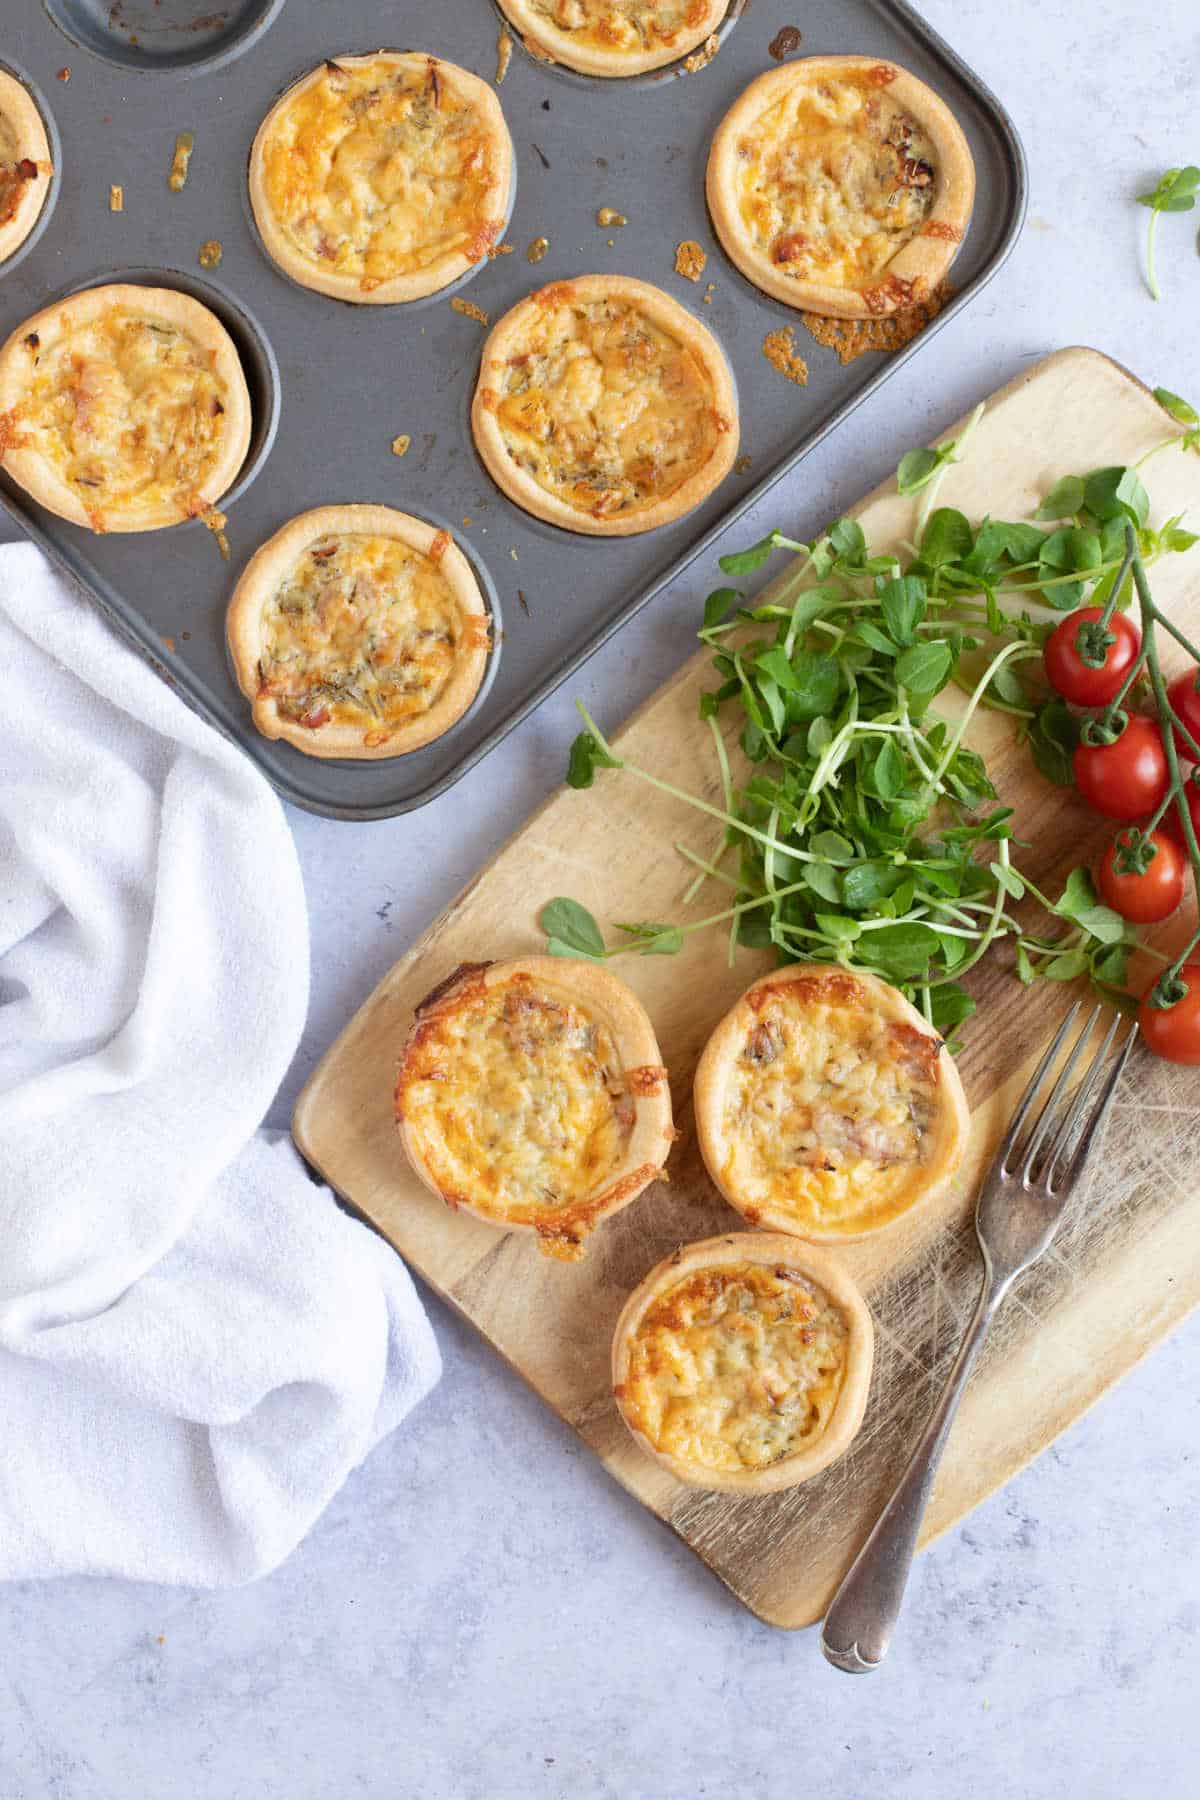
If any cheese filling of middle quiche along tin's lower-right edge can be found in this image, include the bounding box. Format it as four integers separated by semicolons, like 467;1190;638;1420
484;284;729;518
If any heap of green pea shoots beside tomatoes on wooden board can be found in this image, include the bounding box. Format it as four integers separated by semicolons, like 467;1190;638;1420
542;396;1200;1033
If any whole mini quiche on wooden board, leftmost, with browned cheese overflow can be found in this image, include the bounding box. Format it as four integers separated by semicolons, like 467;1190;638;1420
396;956;675;1262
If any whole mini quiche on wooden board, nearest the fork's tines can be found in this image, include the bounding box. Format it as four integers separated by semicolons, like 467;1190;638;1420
694;963;968;1244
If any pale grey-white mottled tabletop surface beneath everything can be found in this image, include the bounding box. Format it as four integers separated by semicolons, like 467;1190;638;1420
0;0;1200;1800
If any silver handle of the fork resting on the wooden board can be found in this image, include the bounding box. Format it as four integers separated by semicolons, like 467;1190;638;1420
820;1278;1007;1676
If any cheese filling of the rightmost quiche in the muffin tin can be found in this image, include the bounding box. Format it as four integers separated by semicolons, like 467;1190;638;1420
734;70;937;288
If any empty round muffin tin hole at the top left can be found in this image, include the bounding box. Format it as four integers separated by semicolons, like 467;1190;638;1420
43;0;284;72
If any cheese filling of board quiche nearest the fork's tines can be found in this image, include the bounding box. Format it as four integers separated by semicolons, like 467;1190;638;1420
723;976;939;1229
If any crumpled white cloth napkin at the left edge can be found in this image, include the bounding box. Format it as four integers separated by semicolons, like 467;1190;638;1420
0;544;439;1586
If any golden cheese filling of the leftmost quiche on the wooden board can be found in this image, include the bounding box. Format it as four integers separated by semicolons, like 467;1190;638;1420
398;974;633;1220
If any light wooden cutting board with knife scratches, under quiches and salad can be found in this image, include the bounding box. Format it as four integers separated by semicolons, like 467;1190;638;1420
293;349;1200;1627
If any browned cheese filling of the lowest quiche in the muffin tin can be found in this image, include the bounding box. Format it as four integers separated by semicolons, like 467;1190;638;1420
259;531;488;743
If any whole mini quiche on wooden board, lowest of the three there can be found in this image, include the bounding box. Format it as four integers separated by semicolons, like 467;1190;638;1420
612;1231;874;1494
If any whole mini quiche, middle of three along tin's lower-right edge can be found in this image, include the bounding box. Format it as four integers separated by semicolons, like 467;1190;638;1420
471;275;738;536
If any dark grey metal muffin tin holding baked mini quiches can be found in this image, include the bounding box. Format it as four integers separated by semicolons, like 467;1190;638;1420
0;0;1025;819
